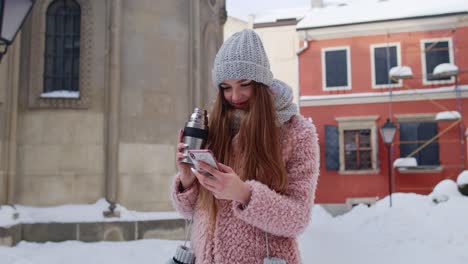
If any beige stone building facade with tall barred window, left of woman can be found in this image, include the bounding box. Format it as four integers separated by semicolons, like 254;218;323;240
0;0;226;210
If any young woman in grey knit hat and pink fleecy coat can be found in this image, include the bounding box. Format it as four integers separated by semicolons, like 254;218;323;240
172;30;319;264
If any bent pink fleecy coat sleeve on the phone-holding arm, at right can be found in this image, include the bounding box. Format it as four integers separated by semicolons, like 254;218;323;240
233;121;320;237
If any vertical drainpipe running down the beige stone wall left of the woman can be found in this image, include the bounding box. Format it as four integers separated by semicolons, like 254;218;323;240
104;0;122;217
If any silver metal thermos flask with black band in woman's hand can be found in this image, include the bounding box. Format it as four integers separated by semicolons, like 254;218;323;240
182;107;208;164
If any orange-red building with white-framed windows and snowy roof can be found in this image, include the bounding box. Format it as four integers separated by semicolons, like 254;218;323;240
297;0;468;208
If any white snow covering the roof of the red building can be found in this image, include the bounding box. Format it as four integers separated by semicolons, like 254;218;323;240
297;0;468;30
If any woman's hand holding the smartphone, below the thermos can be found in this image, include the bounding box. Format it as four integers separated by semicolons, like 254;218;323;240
192;162;251;205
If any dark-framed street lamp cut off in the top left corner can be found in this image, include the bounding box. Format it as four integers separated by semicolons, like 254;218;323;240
0;0;35;61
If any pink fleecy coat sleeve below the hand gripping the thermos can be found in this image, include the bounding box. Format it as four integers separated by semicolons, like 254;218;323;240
171;174;199;219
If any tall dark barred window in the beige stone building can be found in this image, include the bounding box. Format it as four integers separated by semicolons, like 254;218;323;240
43;0;81;93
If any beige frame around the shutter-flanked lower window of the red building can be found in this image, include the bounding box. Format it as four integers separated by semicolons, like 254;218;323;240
336;115;380;174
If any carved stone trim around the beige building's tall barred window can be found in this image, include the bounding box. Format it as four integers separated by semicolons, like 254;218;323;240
28;0;94;109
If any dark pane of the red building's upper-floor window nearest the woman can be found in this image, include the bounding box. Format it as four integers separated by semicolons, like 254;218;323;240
325;50;348;87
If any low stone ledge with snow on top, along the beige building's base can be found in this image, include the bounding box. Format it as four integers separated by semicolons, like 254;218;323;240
0;219;185;246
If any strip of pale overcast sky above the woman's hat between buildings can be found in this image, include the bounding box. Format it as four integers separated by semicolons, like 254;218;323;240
226;0;311;20
